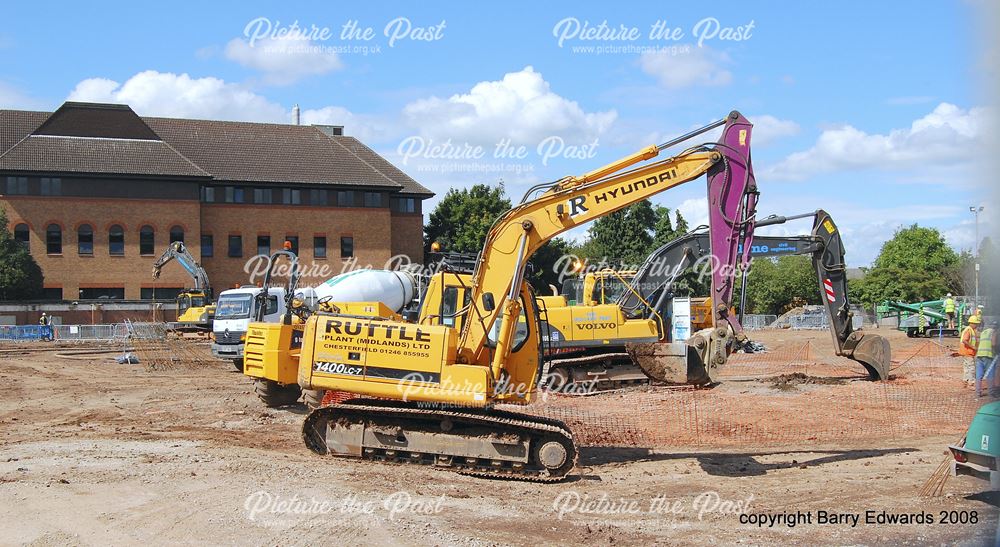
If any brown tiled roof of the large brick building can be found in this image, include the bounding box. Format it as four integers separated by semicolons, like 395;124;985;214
0;102;433;196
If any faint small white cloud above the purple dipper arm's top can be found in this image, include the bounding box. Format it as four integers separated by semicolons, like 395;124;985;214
639;47;733;89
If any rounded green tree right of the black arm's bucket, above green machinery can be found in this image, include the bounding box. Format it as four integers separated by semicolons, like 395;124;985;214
850;224;965;305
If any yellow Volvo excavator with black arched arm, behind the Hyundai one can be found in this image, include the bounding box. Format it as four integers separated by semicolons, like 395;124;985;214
540;210;890;394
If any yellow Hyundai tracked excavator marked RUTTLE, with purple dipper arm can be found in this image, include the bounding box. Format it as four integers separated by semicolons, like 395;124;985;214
245;112;757;482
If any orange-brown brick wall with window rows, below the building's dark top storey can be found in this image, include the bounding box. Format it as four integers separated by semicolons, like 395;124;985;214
0;196;423;300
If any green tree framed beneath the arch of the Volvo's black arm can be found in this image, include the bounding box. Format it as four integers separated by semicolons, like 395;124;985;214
734;256;820;315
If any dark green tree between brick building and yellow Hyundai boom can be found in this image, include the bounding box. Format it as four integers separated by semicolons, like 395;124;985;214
424;183;511;253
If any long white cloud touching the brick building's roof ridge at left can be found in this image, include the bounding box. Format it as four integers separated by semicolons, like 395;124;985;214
67;70;290;123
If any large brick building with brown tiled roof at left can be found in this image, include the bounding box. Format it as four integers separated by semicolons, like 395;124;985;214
0;102;432;300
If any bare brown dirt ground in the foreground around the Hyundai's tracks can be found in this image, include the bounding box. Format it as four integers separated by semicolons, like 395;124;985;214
0;331;1000;545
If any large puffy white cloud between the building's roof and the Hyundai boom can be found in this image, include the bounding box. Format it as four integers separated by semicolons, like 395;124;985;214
403;66;618;146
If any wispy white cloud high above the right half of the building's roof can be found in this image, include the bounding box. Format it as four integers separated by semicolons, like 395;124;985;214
225;36;344;85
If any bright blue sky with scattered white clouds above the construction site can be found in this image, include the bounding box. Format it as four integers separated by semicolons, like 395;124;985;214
0;2;995;265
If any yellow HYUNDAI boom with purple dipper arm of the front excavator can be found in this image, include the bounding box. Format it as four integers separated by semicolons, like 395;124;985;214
458;111;756;386
